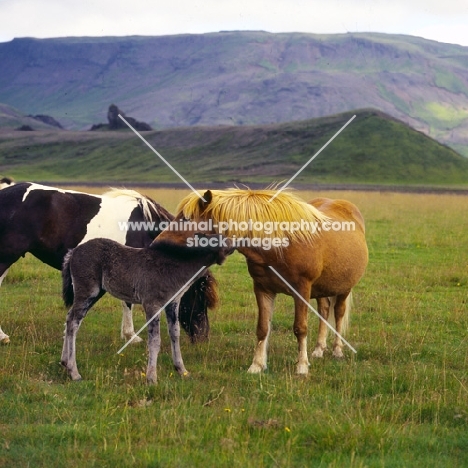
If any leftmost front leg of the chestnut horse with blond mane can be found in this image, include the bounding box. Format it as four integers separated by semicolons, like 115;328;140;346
247;284;276;374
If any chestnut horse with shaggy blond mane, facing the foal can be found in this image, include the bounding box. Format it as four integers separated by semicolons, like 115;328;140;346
176;189;368;375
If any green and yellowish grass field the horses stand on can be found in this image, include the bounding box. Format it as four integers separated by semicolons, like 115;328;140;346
0;191;468;468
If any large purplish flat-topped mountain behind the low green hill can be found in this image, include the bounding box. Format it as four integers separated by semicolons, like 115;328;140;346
0;32;468;155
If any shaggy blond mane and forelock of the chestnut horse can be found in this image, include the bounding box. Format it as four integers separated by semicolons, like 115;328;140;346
177;188;329;242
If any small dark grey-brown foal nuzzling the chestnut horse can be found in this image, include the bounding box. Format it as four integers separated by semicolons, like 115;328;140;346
61;234;234;383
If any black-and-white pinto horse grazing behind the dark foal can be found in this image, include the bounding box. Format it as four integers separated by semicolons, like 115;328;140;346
0;182;218;343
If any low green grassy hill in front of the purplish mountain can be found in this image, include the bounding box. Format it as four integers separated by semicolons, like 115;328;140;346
0;110;468;186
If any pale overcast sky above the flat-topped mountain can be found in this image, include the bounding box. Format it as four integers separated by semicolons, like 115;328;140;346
0;0;468;46
